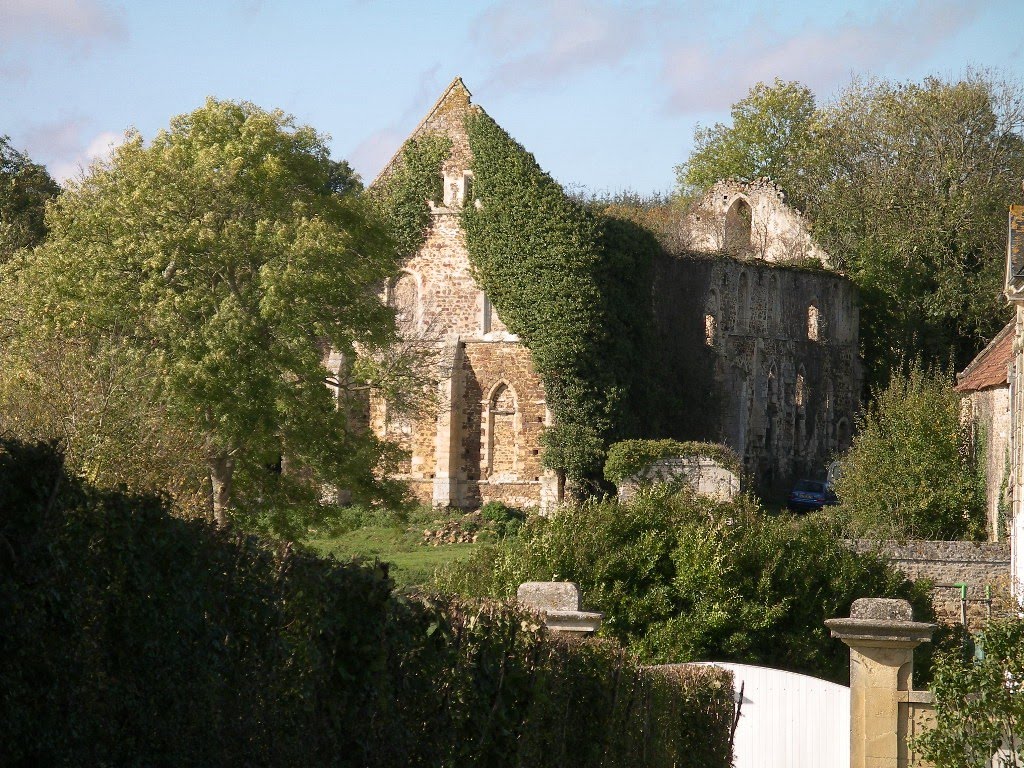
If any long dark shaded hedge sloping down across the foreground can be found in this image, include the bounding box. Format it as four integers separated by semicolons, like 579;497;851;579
0;442;732;768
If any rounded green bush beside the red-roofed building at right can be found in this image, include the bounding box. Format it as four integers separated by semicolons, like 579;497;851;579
836;366;985;539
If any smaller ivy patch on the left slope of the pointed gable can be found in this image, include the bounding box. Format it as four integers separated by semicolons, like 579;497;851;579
370;133;452;257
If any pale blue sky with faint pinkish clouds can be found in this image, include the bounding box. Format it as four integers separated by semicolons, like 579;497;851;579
0;0;1024;195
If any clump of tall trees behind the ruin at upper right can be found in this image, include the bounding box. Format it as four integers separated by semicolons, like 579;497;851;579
680;72;1024;387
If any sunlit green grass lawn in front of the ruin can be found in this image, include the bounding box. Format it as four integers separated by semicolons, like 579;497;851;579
306;525;482;587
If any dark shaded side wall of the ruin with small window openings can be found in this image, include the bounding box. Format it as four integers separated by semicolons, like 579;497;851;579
652;255;861;497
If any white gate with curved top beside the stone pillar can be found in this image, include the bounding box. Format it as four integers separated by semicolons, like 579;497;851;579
696;662;850;768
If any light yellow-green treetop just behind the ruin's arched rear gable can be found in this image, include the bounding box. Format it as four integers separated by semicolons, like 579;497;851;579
676;78;815;197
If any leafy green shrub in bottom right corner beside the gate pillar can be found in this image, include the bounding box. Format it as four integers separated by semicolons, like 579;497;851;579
915;616;1024;768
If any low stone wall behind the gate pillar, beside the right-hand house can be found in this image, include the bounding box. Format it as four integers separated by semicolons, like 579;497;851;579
848;539;1013;632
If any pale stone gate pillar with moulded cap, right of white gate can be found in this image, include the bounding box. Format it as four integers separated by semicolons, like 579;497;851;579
825;598;935;768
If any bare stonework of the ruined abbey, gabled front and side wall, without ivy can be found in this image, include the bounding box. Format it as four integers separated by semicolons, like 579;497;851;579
371;79;861;508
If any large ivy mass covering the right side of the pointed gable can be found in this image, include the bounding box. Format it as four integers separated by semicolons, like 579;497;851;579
462;112;657;482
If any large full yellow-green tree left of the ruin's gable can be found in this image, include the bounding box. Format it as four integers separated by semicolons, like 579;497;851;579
2;98;407;530
